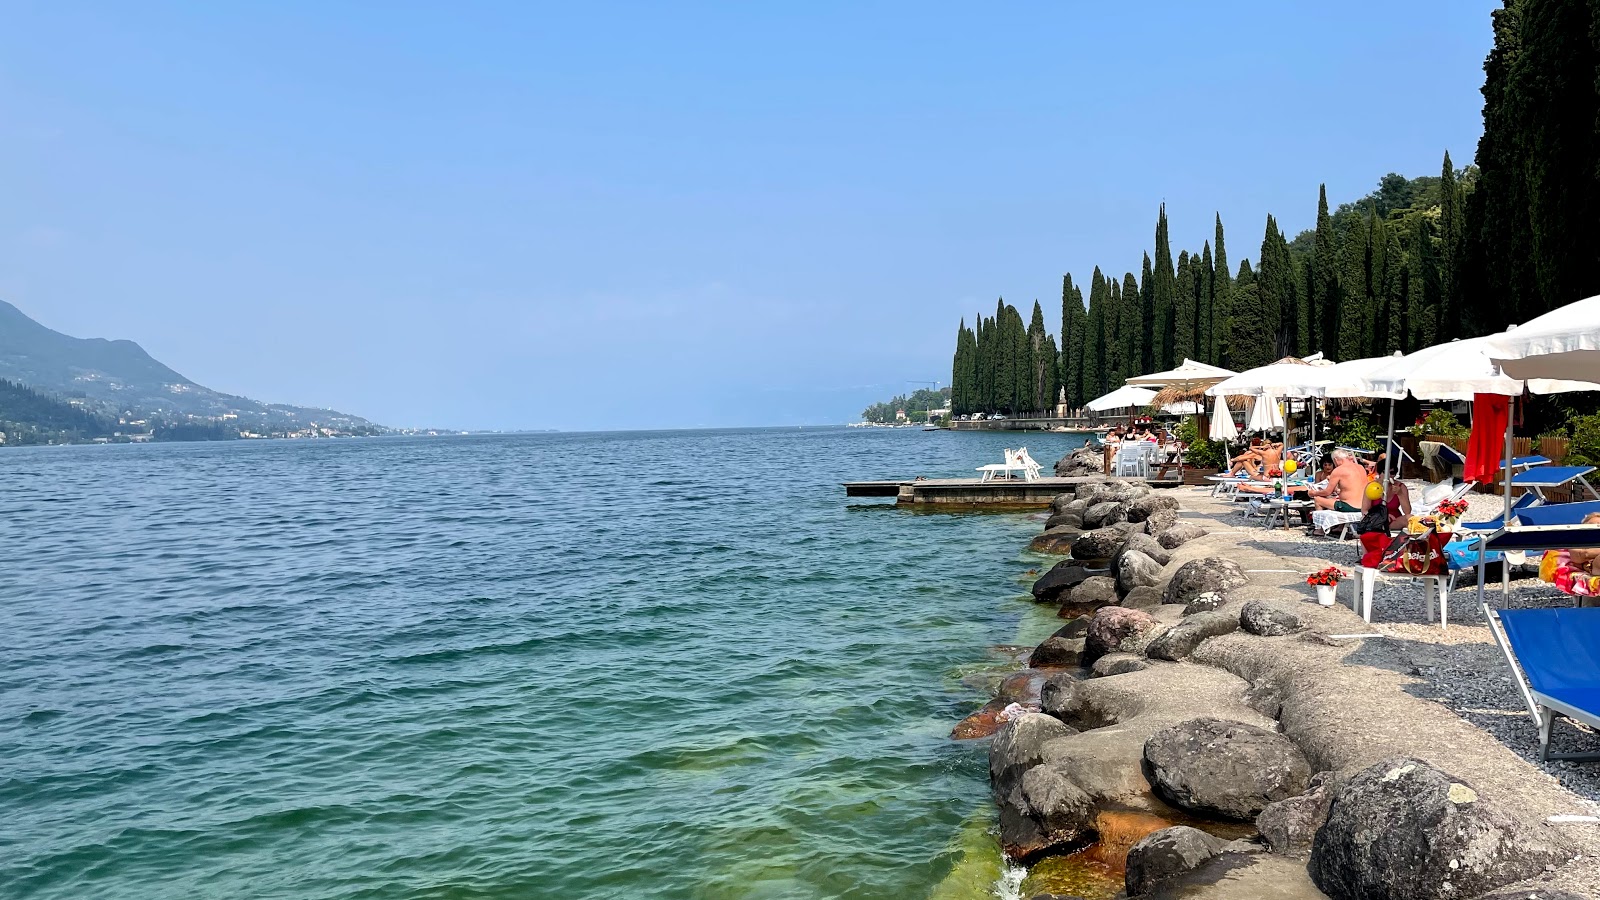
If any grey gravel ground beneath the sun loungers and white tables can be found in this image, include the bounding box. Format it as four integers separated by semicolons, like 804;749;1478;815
1182;482;1600;800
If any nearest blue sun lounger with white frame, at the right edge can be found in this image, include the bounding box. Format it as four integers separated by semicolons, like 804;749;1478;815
1483;604;1600;761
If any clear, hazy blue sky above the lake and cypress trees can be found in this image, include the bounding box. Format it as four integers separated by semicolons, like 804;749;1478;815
0;0;1499;429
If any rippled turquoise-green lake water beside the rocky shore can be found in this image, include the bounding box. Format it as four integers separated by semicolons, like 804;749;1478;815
0;429;1080;898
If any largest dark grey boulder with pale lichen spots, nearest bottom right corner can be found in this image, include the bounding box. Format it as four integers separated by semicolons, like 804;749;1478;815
1309;756;1566;900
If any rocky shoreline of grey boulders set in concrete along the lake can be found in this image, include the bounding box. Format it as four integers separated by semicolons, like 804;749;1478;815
955;452;1600;900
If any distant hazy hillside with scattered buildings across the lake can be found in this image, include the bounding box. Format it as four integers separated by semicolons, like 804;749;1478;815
0;301;381;432
